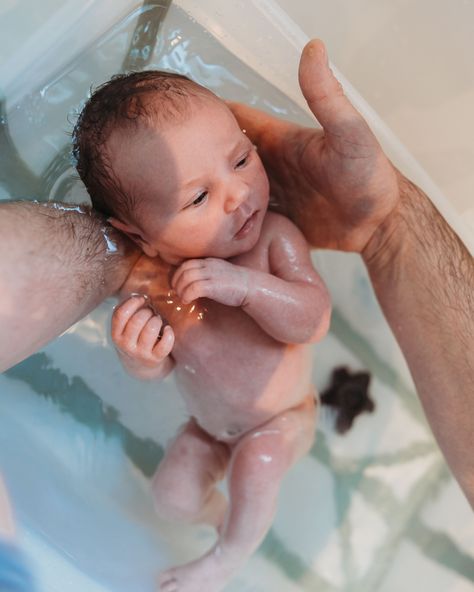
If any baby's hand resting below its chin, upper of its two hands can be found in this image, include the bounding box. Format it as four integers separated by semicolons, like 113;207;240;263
171;257;248;306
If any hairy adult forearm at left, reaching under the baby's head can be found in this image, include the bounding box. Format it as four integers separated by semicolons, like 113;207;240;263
0;202;138;371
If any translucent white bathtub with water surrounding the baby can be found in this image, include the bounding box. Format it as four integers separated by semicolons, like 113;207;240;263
0;0;474;592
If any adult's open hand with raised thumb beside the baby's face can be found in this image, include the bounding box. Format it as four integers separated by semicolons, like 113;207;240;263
229;40;400;252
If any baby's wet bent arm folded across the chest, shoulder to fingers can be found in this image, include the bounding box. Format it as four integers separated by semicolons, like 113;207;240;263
172;213;331;343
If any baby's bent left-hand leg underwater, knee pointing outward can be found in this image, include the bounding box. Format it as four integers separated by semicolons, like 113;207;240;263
152;420;230;528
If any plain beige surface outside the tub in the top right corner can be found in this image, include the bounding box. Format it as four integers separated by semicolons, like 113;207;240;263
277;0;474;235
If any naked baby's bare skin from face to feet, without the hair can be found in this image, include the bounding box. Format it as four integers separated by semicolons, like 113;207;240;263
108;99;330;592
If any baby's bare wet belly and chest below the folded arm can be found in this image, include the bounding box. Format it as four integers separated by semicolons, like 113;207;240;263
173;307;312;441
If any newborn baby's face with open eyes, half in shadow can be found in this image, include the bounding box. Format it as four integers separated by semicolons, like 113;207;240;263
111;98;269;264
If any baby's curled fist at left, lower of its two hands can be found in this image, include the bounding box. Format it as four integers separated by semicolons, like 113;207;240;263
112;296;174;380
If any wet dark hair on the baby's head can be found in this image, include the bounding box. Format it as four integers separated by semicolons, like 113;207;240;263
72;70;215;220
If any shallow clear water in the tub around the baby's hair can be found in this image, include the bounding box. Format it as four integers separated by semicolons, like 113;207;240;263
0;0;308;202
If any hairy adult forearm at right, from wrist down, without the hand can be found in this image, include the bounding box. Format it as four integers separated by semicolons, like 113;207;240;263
363;176;474;506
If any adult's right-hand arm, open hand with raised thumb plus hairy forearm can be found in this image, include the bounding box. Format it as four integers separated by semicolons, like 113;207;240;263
231;40;474;507
